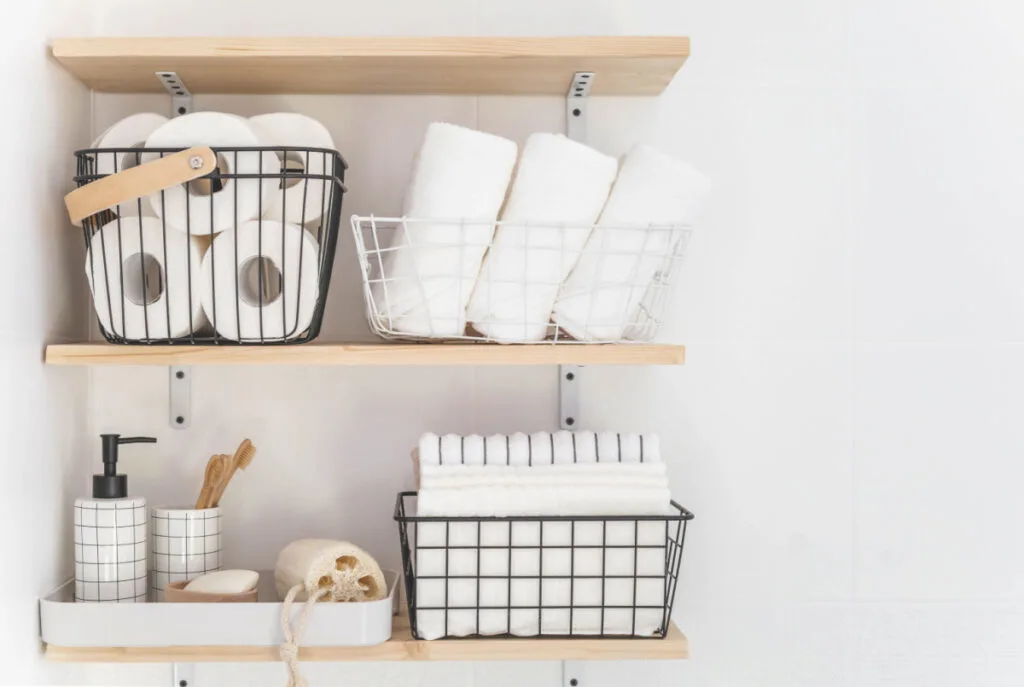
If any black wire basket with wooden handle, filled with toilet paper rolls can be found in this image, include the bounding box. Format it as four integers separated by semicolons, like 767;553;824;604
66;146;347;345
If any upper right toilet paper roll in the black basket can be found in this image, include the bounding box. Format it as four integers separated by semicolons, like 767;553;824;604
249;113;334;224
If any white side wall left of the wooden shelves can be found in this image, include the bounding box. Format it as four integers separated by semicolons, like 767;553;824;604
0;0;91;685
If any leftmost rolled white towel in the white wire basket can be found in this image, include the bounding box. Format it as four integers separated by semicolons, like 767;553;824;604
371;123;517;338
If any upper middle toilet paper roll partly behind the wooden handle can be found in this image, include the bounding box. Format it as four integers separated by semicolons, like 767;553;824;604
143;113;281;234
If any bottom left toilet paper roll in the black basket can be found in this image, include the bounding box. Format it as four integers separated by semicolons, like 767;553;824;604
85;217;206;339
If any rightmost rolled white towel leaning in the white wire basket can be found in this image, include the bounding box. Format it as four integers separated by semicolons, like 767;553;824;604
554;145;711;341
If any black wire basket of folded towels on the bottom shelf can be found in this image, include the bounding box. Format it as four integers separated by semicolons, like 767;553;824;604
394;491;693;640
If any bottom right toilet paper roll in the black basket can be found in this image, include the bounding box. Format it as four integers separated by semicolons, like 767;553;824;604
203;220;319;343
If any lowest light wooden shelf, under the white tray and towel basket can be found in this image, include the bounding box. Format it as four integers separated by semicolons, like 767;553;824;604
46;615;690;663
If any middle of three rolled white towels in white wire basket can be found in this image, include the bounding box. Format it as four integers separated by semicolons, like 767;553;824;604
467;133;617;343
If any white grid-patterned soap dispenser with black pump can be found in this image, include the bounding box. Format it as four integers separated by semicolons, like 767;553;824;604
75;434;157;603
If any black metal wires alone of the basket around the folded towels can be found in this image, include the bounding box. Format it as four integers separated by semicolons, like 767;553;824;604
394;491;693;639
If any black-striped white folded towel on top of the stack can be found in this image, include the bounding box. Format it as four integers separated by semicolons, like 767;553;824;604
419;432;662;466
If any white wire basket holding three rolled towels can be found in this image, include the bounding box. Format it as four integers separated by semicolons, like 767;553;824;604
352;215;692;344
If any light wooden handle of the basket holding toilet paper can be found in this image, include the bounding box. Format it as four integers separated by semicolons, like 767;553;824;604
65;145;217;222
